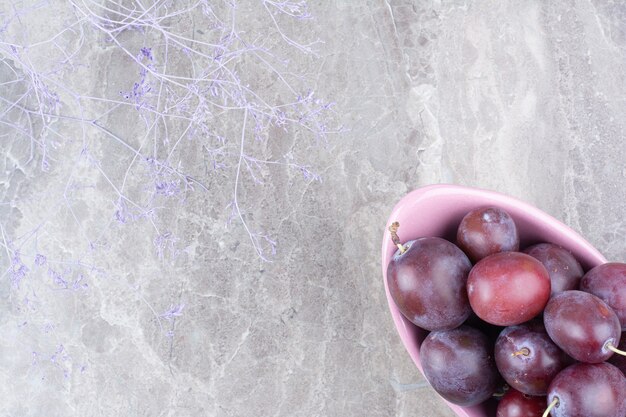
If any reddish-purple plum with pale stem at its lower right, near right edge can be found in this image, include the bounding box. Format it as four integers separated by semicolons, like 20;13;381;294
543;291;623;362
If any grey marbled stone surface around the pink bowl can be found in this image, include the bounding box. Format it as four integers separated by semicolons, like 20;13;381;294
0;0;626;417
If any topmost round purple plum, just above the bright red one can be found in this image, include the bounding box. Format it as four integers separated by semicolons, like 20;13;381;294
456;207;519;262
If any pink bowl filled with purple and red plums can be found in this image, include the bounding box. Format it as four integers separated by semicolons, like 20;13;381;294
382;185;626;417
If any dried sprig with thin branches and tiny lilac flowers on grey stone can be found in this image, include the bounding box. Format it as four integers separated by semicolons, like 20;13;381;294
0;0;341;384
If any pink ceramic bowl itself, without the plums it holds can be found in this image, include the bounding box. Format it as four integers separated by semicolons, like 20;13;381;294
382;185;606;417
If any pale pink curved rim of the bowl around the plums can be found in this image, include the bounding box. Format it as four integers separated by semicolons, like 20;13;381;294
381;184;607;417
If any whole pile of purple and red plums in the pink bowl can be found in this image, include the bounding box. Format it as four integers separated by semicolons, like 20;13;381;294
387;207;626;417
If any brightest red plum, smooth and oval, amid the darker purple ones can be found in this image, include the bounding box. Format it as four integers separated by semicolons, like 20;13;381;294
467;252;550;326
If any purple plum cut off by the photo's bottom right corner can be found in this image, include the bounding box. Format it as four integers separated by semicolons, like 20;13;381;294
547;363;626;417
